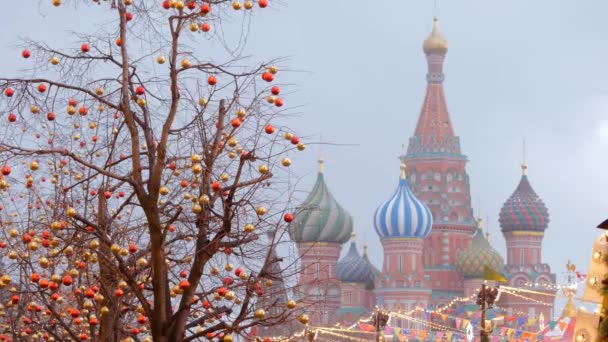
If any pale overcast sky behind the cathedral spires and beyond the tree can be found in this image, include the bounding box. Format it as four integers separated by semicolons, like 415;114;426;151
0;0;608;298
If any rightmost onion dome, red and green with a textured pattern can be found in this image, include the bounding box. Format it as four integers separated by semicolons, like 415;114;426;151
499;163;549;232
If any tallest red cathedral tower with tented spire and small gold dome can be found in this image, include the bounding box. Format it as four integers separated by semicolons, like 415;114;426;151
402;18;476;303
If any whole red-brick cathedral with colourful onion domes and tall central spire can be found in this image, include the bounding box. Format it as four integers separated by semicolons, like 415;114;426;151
290;18;556;326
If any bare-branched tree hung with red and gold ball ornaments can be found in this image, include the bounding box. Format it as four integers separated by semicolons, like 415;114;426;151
0;0;306;341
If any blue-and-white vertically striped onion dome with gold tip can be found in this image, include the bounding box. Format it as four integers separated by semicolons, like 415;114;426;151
374;164;433;239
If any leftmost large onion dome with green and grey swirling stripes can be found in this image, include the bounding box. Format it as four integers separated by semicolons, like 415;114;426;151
290;159;353;243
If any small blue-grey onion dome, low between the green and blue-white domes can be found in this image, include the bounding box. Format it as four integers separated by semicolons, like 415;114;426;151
336;233;375;285
